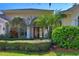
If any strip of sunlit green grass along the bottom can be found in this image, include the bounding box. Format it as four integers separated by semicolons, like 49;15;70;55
0;51;79;56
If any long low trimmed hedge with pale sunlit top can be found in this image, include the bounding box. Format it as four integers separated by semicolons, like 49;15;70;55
0;40;51;52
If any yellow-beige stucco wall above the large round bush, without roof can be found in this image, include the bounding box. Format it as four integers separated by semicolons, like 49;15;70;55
62;8;79;26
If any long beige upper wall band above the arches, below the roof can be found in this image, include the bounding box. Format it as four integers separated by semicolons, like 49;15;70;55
5;10;52;16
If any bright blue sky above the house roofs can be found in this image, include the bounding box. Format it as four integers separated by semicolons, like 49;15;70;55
0;3;73;10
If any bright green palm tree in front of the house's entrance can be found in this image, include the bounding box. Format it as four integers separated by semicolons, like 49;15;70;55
34;12;66;38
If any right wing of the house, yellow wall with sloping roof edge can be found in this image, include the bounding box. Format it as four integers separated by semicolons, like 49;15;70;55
62;4;79;26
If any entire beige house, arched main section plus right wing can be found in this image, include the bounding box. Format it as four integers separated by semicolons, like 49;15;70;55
0;4;79;38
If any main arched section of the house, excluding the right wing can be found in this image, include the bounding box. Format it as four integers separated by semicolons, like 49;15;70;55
0;9;53;38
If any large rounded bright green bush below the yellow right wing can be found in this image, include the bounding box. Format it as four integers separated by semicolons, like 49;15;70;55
52;26;79;49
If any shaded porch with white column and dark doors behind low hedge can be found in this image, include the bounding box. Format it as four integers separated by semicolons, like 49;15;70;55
8;26;48;39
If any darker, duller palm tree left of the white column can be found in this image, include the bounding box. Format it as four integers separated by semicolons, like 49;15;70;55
9;17;26;37
